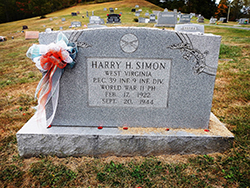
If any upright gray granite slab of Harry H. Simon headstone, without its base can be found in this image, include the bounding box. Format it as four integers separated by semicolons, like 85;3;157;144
39;28;221;128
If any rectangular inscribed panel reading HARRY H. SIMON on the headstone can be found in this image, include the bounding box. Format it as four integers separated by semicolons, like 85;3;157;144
87;58;171;108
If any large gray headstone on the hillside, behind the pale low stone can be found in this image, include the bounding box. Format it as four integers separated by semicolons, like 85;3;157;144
155;12;177;27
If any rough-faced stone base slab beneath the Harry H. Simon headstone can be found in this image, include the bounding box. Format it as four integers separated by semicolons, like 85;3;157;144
16;113;234;157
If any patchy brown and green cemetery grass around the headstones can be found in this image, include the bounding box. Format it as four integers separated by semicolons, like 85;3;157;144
0;1;250;187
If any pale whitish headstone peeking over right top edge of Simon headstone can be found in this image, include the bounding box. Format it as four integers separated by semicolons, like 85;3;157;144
175;24;204;34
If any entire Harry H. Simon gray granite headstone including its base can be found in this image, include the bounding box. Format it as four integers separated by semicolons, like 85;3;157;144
17;27;233;157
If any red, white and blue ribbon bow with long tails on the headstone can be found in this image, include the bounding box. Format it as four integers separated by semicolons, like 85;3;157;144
26;32;77;127
